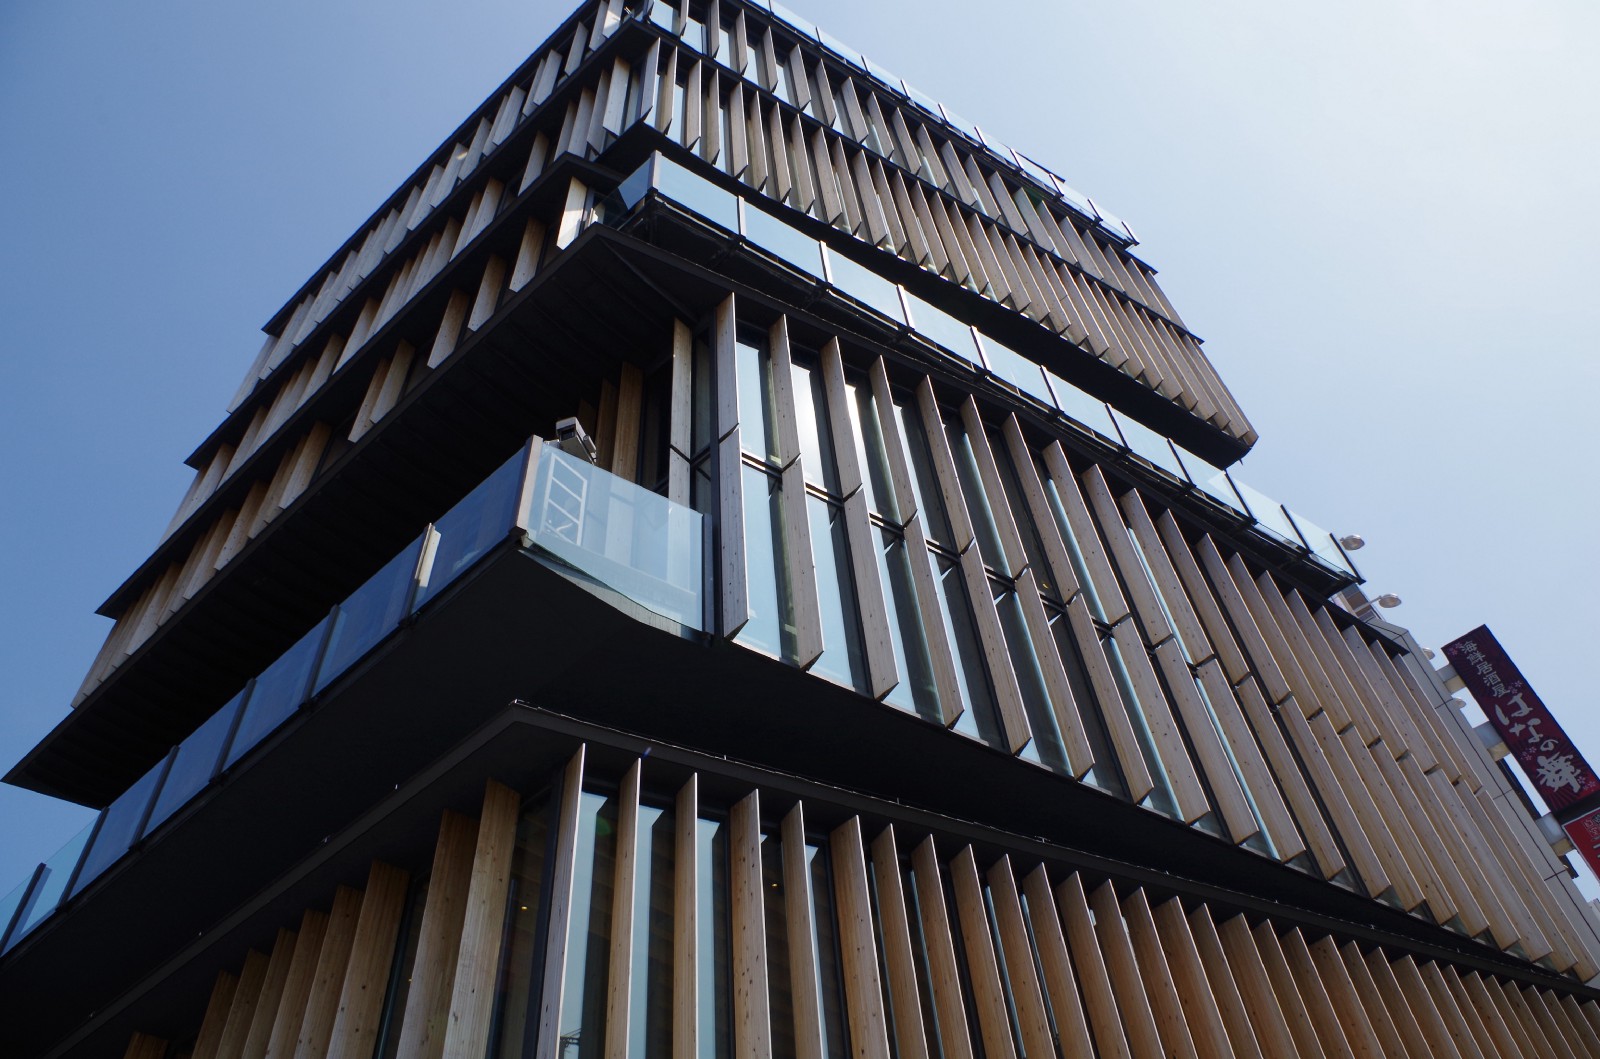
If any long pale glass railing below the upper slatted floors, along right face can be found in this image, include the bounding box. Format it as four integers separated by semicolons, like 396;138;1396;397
597;154;1360;579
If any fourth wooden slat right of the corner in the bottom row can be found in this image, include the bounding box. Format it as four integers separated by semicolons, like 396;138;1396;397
728;790;773;1059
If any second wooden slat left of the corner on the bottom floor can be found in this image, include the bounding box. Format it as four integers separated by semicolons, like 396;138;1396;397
395;811;478;1059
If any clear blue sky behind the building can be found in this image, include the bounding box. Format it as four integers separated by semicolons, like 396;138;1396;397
0;0;1600;894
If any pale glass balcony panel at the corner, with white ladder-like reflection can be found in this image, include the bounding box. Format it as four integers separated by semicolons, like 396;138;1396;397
528;445;704;629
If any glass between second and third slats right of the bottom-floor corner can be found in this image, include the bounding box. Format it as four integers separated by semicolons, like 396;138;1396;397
627;805;677;1059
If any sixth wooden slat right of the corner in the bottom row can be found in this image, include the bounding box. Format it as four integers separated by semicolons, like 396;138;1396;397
829;816;890;1059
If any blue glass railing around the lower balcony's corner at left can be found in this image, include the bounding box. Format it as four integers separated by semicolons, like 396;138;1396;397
0;442;706;953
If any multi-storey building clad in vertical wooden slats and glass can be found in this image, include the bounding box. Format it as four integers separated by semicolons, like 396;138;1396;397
0;0;1600;1059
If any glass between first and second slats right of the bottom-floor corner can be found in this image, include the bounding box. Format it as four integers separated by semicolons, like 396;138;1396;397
557;790;616;1059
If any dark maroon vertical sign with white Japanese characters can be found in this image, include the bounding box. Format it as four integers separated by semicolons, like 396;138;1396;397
1445;625;1600;812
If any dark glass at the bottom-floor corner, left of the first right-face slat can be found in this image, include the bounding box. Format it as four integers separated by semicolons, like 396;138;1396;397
485;800;550;1059
